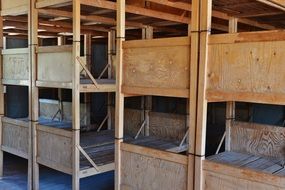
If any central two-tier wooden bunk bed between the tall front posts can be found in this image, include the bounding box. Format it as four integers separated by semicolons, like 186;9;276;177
117;28;193;189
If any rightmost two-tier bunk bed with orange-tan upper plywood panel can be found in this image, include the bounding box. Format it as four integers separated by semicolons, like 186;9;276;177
203;31;285;189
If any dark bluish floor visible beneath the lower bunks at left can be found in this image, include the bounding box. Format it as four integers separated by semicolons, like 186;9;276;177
0;153;114;190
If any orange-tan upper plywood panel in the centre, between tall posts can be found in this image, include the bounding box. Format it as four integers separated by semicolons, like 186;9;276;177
123;37;190;97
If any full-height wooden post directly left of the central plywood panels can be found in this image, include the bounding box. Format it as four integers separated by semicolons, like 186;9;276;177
115;0;126;190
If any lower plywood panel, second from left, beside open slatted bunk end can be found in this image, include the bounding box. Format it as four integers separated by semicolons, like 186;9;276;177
37;125;72;174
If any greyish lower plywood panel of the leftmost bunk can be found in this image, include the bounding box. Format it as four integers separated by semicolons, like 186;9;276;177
2;117;30;159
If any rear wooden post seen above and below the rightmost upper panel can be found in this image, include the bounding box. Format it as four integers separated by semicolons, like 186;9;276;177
225;18;238;151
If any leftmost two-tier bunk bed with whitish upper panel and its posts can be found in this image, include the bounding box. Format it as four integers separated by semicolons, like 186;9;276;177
0;0;32;188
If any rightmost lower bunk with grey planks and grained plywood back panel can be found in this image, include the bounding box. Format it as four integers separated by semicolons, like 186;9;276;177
203;121;285;190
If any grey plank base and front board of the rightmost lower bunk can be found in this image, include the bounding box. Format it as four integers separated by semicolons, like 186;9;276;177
203;152;285;190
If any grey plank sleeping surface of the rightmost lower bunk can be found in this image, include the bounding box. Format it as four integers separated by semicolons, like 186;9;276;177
207;152;285;176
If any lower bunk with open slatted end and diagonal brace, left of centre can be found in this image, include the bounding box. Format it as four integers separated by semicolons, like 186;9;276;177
36;120;115;178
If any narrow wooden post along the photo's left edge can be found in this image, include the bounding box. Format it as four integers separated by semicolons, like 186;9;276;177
0;10;5;177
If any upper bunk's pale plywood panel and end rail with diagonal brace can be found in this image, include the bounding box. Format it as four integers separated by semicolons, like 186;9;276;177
36;45;116;93
